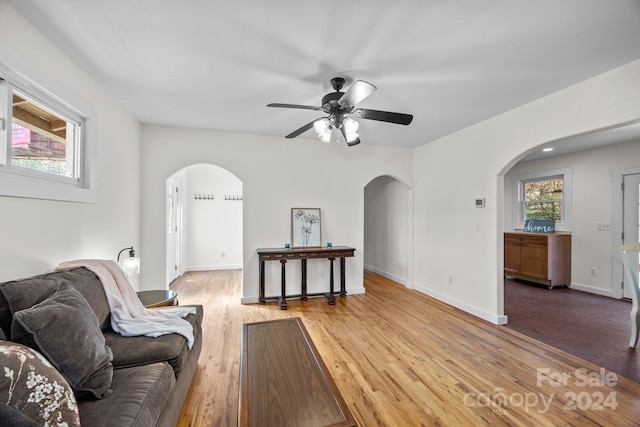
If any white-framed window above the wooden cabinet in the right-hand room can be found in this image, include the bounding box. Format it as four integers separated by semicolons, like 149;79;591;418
513;169;573;231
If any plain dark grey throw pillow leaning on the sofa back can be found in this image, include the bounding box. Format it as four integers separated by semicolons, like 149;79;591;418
11;283;113;399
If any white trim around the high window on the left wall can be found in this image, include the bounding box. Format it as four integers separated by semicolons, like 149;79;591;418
0;54;99;203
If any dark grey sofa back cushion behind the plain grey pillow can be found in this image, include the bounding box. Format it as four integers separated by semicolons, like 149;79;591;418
0;267;111;336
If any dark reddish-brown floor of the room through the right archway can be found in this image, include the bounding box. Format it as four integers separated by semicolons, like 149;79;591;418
504;279;640;382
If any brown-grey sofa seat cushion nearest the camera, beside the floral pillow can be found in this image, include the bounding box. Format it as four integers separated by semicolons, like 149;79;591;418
78;362;176;427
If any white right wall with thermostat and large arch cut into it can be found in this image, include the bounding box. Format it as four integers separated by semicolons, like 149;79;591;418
413;61;640;323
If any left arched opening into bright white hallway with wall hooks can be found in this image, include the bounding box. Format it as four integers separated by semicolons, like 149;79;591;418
165;164;243;285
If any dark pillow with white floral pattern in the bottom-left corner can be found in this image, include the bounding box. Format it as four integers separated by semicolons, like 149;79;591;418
0;341;80;427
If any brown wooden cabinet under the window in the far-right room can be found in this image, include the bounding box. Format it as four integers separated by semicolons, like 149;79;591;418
504;233;571;289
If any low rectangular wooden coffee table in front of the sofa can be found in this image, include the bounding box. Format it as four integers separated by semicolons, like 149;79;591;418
238;317;356;427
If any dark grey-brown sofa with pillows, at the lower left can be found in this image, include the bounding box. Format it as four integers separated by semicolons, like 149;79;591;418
0;267;203;427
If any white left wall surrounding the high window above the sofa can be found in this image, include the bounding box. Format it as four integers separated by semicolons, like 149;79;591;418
0;1;144;281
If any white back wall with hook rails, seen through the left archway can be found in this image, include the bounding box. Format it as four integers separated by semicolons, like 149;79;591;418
184;165;242;271
